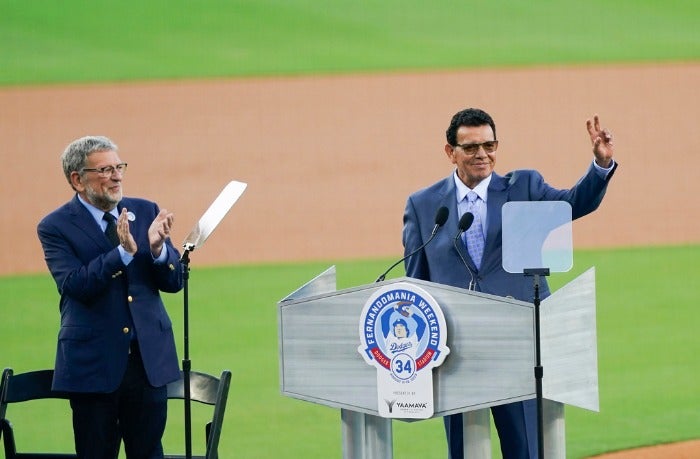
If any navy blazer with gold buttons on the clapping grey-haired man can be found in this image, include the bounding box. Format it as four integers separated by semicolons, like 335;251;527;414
37;195;182;393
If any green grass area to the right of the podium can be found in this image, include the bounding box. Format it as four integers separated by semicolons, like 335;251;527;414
555;246;700;457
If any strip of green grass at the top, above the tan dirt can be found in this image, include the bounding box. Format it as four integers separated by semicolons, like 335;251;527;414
0;0;700;85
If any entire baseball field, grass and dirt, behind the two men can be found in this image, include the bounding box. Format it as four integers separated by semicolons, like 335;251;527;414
0;0;700;458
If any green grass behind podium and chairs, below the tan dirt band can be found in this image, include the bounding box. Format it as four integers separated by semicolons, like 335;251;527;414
0;246;700;459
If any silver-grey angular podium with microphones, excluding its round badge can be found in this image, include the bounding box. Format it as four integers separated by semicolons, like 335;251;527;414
278;267;599;459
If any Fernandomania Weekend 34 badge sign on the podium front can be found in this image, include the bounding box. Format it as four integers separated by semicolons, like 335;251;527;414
358;282;450;419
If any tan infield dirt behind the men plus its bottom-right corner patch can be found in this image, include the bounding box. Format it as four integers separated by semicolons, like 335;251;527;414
0;64;700;459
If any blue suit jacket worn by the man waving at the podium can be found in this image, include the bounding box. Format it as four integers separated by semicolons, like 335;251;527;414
403;164;617;301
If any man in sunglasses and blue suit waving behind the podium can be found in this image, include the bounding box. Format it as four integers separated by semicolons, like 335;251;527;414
403;108;617;459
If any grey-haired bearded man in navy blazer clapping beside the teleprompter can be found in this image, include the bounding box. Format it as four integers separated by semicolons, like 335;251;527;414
37;136;182;459
